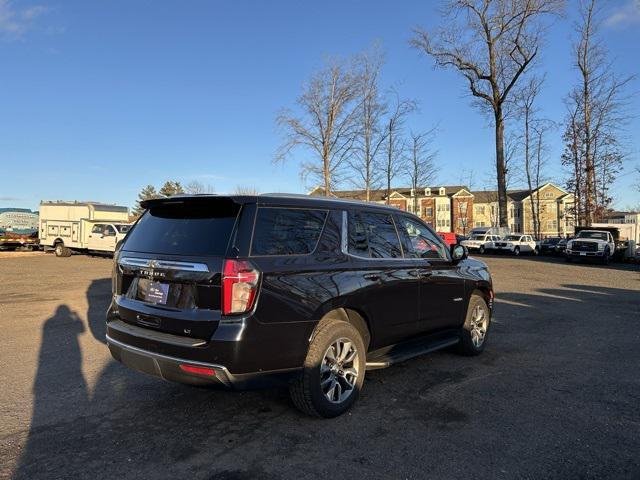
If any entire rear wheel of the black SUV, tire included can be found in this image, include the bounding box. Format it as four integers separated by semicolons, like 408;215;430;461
289;320;367;418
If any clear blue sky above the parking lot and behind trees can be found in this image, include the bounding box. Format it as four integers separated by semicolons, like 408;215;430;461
0;0;640;208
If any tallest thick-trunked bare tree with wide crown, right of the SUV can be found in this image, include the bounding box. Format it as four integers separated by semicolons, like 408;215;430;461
411;0;564;227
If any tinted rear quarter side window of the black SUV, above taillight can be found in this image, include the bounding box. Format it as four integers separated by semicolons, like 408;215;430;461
251;207;328;256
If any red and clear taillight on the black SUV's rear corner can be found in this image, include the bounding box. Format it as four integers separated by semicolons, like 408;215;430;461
222;260;260;315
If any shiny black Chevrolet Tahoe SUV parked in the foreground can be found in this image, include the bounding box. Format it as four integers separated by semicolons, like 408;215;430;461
107;194;493;417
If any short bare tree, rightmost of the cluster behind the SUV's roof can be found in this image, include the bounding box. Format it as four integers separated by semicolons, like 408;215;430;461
404;129;438;213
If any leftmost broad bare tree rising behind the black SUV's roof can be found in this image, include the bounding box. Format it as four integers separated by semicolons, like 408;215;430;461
275;60;360;196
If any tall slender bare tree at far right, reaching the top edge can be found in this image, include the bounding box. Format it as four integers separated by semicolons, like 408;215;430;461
563;0;633;225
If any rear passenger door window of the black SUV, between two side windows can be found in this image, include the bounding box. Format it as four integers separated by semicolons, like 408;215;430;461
348;212;402;258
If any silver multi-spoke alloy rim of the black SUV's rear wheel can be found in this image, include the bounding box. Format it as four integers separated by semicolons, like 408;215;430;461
320;338;359;403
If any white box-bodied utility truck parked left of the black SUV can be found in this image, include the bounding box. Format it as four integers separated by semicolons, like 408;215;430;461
39;201;130;257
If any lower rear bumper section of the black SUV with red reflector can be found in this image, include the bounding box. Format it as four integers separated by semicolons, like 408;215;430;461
106;335;300;390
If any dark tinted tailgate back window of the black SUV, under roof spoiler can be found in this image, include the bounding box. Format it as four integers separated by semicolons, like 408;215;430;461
124;202;240;255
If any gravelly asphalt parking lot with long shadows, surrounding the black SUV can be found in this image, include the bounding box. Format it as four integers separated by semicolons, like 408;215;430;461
0;254;640;480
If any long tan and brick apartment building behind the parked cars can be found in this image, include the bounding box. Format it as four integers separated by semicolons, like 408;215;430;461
309;183;574;237
